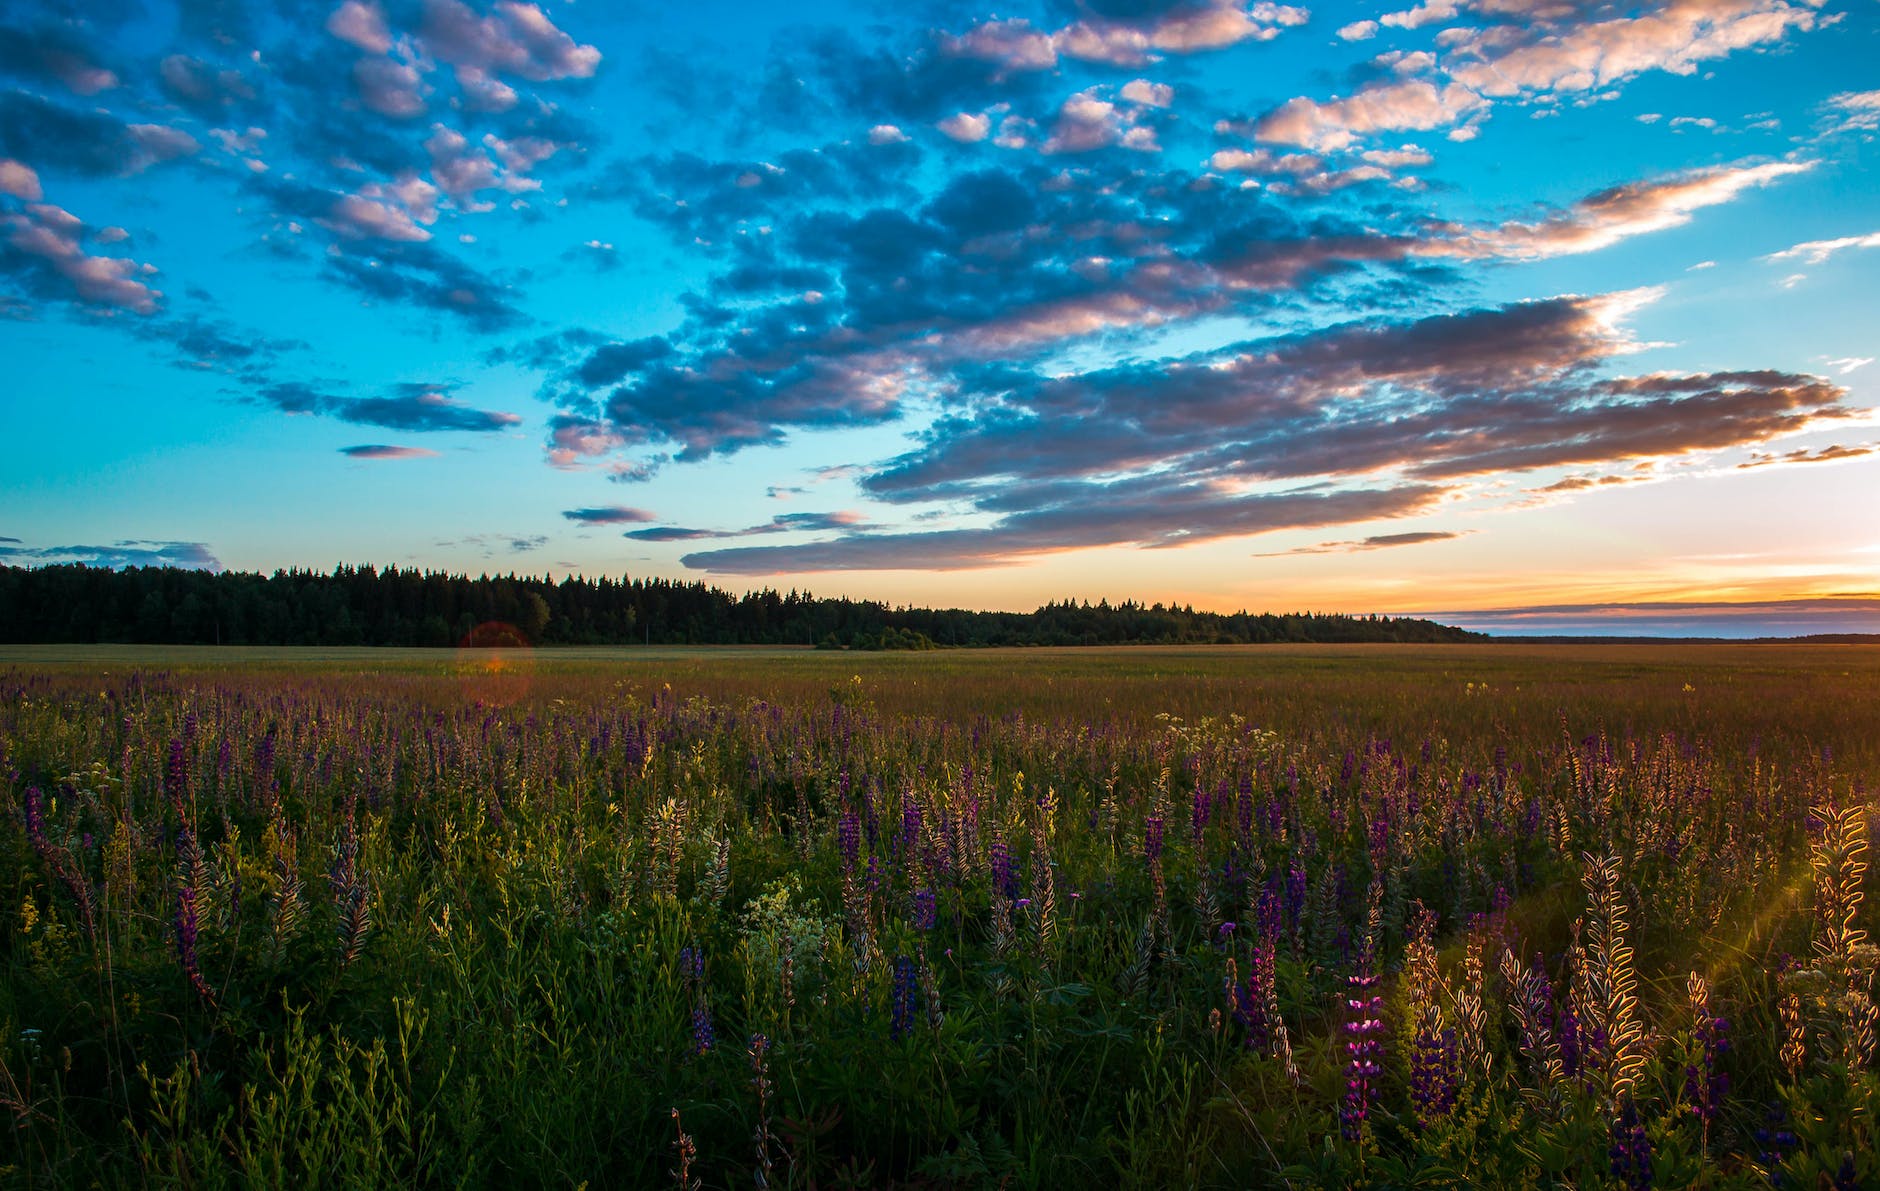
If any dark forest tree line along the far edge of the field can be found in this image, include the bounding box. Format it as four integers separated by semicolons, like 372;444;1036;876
0;565;1483;650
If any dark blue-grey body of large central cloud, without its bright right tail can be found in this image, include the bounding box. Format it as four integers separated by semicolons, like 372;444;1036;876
549;156;1428;460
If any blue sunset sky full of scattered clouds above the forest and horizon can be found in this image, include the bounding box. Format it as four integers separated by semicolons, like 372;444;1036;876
0;0;1880;635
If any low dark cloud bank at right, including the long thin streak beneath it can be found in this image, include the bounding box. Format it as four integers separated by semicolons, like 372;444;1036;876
654;295;1846;573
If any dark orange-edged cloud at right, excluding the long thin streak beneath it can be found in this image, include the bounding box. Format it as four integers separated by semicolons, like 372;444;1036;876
865;299;1844;502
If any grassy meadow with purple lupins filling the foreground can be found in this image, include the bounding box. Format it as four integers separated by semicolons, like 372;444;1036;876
0;644;1880;1187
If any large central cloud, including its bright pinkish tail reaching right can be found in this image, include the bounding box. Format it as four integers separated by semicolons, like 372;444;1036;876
545;147;1805;484
